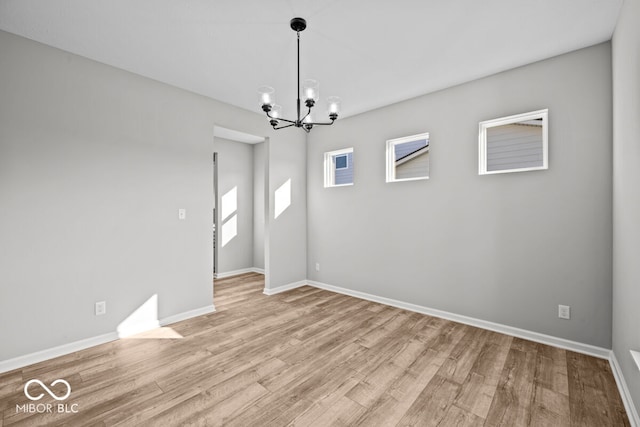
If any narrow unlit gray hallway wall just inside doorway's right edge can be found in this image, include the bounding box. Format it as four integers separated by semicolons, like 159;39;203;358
253;142;267;269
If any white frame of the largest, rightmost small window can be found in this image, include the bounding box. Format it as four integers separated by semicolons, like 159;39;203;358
478;108;549;175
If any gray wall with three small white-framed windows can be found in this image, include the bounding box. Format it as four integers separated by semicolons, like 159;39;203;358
307;43;612;348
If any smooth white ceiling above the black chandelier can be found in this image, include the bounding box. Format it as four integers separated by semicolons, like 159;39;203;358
0;0;622;120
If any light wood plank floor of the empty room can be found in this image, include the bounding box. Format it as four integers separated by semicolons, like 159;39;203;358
0;274;629;427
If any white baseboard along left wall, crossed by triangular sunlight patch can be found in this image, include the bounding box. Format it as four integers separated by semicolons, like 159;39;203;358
0;304;215;374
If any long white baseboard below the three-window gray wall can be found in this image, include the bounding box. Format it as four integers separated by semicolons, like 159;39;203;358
307;280;611;359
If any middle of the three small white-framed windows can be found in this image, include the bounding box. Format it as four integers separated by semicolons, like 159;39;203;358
387;133;429;182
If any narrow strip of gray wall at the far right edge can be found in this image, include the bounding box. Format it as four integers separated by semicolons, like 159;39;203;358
612;0;640;414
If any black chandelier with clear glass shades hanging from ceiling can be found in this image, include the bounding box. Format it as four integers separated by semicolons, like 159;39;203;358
258;18;340;133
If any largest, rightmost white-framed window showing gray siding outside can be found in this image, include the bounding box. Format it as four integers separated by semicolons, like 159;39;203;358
478;110;549;175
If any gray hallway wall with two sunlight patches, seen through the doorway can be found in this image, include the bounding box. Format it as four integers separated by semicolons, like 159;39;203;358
213;137;255;274
